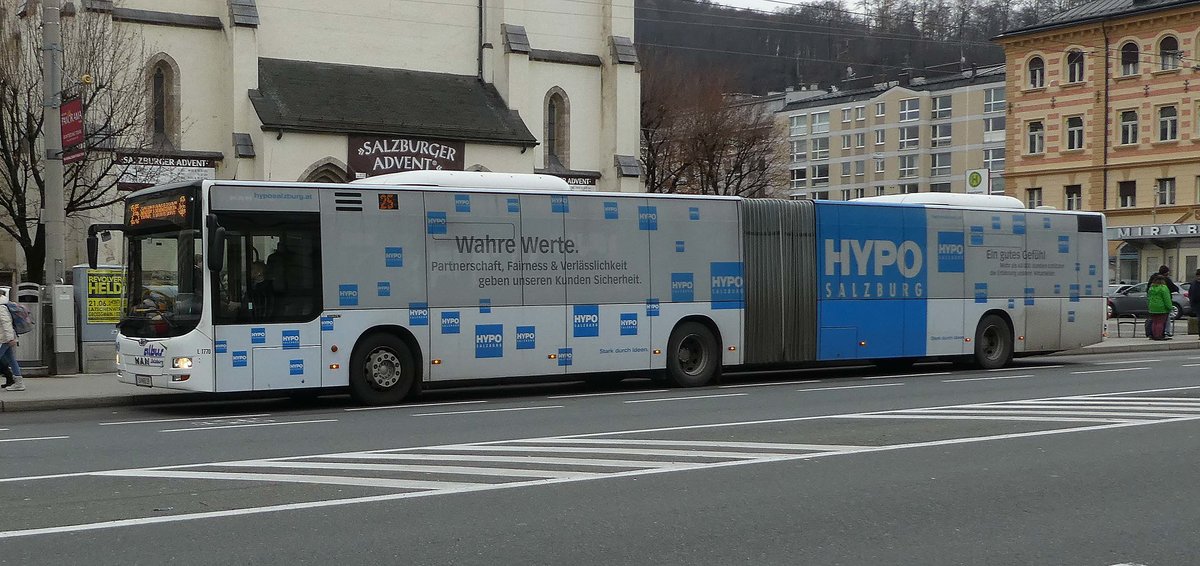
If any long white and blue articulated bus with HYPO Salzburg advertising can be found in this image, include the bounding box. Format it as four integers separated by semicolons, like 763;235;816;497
89;171;1106;404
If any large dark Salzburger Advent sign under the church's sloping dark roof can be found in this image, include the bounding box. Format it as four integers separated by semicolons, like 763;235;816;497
346;136;467;179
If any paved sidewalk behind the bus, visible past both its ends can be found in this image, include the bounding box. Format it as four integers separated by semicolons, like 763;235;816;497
7;321;1200;413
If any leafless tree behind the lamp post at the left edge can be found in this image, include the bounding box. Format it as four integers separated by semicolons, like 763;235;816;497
0;0;150;282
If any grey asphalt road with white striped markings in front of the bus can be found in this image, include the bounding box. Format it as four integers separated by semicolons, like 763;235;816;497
0;351;1200;566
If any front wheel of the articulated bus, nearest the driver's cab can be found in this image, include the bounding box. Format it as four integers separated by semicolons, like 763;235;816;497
350;332;418;405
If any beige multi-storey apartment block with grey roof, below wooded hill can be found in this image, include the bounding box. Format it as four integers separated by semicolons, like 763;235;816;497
780;66;1006;200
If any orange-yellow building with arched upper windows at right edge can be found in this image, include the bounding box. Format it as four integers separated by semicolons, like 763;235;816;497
996;0;1200;282
